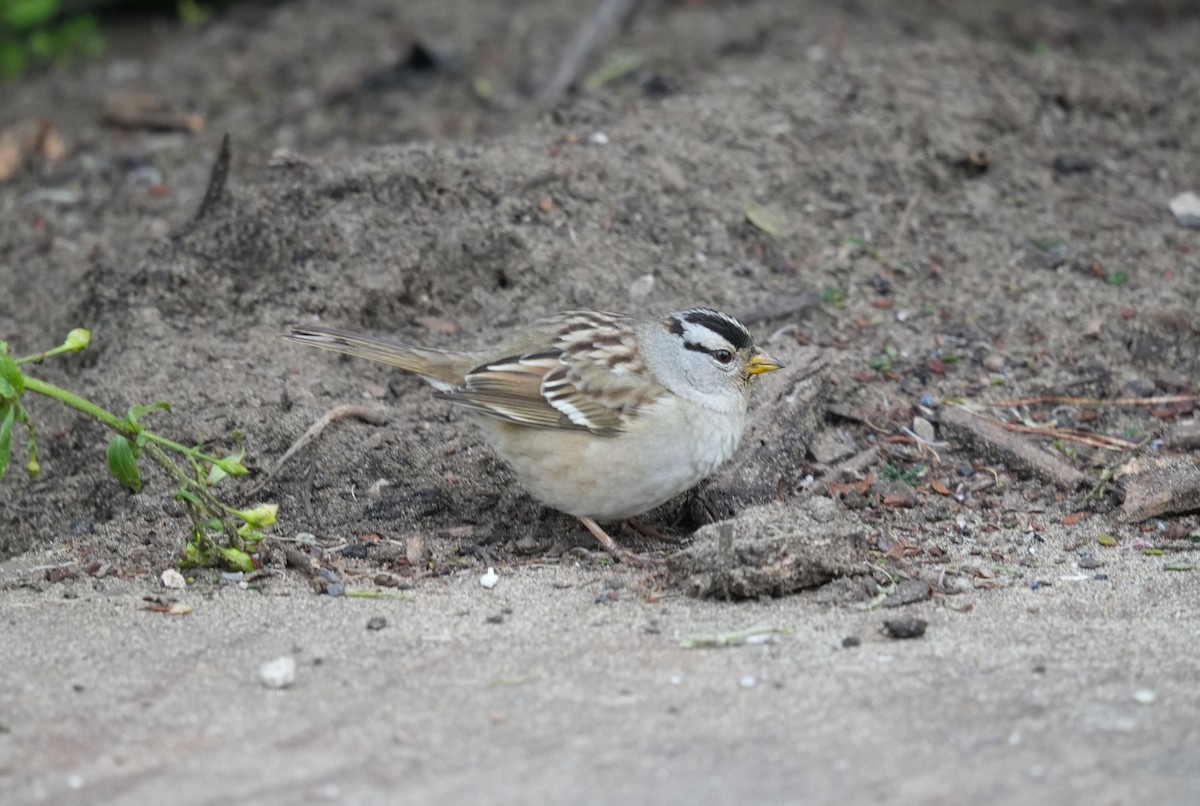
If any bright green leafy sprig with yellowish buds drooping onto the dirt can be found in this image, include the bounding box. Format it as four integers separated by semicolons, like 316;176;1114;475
0;327;278;571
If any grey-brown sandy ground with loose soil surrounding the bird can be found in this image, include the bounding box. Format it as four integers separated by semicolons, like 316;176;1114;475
0;0;1200;805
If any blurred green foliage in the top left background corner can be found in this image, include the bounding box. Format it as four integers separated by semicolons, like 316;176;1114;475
0;0;104;78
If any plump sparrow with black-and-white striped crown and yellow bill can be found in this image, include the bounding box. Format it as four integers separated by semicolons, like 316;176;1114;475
288;308;782;563
